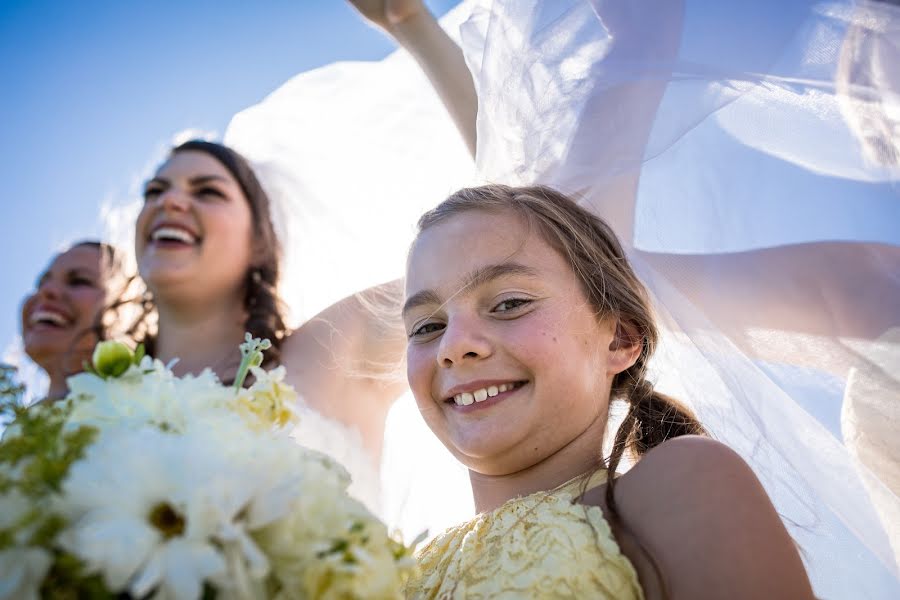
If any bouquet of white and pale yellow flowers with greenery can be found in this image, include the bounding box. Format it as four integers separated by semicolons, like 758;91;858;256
0;334;414;599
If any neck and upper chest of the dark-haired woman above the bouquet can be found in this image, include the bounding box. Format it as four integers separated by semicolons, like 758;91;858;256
155;292;246;379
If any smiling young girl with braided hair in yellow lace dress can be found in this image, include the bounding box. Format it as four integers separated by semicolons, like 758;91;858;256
403;186;812;598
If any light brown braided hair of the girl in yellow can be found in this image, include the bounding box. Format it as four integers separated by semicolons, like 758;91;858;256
419;185;705;519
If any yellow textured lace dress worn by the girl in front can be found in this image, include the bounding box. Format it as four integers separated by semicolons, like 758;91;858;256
406;473;644;600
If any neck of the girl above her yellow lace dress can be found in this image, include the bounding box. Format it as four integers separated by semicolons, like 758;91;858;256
469;415;606;513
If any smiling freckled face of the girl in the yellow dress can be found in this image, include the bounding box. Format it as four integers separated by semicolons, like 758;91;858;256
404;211;628;475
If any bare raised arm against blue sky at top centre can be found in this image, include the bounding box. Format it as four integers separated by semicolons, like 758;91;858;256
349;0;478;156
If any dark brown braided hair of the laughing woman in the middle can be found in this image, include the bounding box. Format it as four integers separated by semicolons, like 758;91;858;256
138;140;288;365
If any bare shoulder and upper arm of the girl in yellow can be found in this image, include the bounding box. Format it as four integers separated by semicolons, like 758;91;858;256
583;436;812;598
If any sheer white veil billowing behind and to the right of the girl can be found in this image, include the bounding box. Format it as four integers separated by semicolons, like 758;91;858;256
462;0;900;598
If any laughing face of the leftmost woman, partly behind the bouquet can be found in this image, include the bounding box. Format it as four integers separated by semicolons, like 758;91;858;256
22;245;108;368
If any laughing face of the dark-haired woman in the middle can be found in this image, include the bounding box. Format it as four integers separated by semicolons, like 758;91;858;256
135;151;253;297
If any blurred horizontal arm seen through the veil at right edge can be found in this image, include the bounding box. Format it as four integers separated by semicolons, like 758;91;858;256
641;242;900;376
